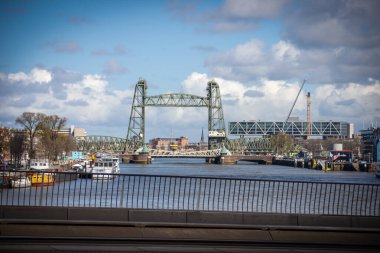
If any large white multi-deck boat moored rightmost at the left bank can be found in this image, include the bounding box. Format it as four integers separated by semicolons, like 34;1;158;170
92;156;120;180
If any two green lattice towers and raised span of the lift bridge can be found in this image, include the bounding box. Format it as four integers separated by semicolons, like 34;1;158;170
125;80;226;153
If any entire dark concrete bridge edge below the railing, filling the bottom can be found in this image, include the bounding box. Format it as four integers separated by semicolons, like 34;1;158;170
0;206;380;252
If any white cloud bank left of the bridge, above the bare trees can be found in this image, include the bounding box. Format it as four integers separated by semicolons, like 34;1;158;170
0;68;133;136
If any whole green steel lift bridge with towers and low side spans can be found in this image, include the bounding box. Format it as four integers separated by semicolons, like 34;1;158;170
76;80;271;157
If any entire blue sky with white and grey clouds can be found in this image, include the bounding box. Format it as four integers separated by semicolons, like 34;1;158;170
0;0;380;142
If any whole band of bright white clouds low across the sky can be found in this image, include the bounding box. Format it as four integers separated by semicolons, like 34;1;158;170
0;66;380;141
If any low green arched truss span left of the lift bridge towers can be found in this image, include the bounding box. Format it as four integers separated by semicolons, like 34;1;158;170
75;135;125;153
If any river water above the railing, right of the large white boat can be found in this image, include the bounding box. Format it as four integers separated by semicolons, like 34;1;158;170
121;158;380;184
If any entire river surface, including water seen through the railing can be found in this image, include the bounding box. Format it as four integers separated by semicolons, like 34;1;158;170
0;158;380;216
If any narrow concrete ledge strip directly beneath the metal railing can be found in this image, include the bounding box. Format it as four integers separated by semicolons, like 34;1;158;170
0;206;380;228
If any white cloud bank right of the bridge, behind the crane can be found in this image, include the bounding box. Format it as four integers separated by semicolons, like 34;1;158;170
176;72;380;133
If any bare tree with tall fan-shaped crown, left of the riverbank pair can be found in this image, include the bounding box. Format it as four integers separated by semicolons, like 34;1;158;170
16;112;46;158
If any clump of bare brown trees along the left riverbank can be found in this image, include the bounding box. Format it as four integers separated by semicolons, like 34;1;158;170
0;112;75;167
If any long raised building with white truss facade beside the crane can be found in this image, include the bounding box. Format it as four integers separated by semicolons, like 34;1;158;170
228;117;354;139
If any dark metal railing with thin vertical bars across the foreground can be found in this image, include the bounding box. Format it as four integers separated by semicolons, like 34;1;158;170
0;172;380;216
